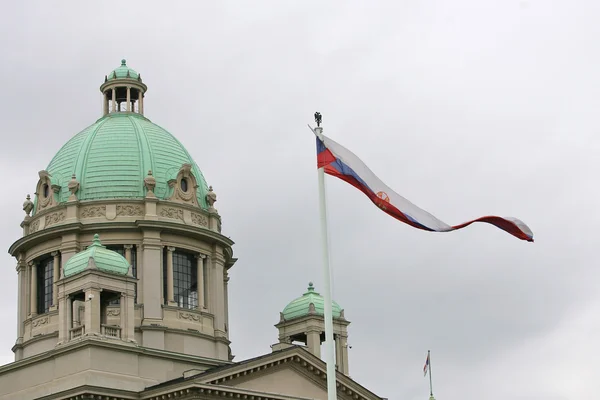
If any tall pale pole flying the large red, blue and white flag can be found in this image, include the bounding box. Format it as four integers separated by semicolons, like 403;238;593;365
315;113;337;400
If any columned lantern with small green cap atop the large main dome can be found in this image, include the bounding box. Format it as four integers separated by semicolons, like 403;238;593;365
100;59;148;115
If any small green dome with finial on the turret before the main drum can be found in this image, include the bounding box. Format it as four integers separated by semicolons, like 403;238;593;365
64;234;129;277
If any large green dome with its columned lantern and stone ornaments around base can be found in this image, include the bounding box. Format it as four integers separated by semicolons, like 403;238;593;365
34;60;209;213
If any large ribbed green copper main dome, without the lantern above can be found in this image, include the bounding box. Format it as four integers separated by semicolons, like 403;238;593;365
36;113;208;208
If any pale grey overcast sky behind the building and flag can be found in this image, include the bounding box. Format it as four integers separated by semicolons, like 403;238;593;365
0;0;600;400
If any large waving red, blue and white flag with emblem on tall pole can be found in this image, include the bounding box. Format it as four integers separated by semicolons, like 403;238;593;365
311;132;533;242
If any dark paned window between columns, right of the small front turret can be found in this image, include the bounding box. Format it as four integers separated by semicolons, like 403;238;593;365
163;250;198;309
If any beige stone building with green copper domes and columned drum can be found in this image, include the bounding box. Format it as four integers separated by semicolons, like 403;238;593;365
0;60;379;400
